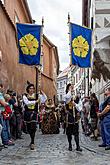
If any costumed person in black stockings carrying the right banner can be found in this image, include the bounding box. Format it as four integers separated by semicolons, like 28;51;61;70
65;84;82;151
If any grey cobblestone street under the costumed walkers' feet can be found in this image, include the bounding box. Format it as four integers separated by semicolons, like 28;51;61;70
0;131;110;165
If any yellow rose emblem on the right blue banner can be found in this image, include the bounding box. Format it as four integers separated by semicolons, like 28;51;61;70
72;35;89;58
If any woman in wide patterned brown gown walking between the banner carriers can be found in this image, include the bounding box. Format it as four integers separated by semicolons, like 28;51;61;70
41;99;59;134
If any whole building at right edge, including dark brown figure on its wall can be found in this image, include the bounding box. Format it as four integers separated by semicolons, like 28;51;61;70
83;0;110;102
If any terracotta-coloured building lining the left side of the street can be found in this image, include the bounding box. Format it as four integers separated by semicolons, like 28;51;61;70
0;0;59;98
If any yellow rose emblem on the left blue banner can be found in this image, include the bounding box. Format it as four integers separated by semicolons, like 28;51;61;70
19;33;39;55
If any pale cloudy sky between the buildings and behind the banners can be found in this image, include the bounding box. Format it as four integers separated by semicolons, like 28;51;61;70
28;0;82;70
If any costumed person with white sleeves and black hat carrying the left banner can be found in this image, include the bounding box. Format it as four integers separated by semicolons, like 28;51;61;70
23;84;38;150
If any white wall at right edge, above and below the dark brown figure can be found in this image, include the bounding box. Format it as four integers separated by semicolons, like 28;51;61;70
91;0;110;102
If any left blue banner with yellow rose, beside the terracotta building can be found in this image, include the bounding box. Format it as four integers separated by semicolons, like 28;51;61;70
17;23;42;65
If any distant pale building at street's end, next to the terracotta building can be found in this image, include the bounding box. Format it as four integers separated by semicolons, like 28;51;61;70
57;67;70;102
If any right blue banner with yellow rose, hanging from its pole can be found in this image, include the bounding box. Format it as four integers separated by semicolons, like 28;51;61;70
70;23;92;68
